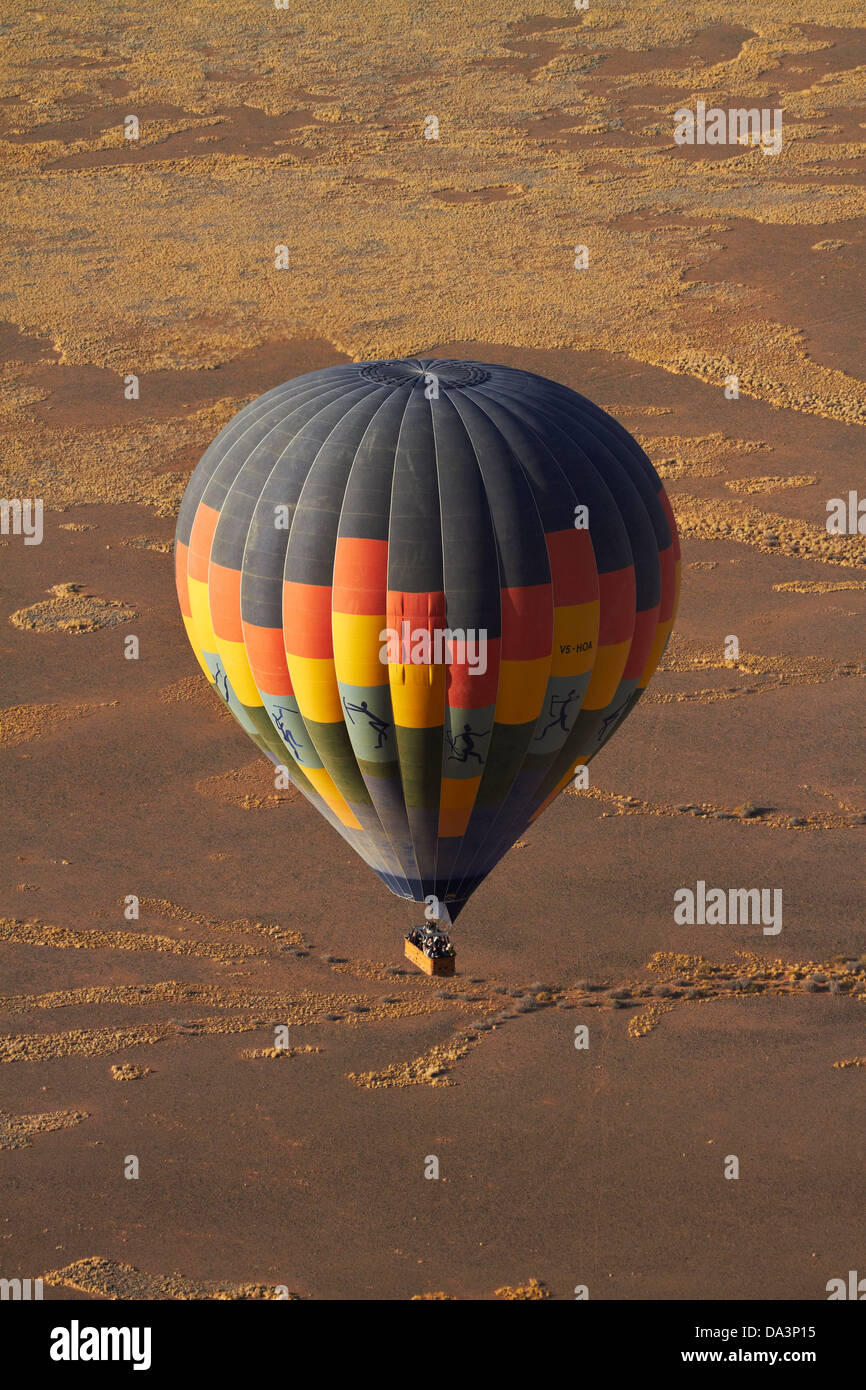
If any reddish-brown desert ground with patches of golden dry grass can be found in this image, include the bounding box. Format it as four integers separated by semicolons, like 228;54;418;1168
0;0;866;1300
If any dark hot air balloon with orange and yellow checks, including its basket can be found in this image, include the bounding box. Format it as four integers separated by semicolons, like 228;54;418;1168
175;357;680;973
